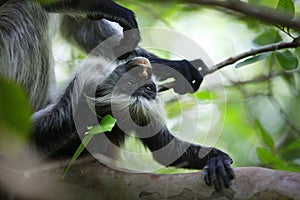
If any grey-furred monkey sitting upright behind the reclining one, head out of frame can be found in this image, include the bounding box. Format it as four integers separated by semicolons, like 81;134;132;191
0;0;202;111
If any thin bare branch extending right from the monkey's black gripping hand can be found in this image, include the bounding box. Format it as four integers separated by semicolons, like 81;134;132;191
201;37;300;76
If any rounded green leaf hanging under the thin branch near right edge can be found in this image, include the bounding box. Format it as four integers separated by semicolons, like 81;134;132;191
276;50;298;70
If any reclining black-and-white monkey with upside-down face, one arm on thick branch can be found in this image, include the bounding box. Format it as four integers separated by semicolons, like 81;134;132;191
33;57;233;190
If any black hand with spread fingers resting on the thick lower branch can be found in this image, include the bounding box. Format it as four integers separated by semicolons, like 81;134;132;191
203;152;234;191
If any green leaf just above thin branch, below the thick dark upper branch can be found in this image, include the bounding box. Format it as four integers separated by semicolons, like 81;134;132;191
253;29;282;46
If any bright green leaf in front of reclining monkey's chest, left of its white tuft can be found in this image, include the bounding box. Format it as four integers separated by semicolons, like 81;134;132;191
85;115;117;135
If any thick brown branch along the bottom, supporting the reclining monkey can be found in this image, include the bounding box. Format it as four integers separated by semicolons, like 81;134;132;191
0;157;300;200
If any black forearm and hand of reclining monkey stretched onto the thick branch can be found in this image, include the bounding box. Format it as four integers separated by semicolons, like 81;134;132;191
141;128;234;190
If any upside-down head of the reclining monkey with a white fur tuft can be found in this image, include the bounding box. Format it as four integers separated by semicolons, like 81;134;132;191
97;57;163;126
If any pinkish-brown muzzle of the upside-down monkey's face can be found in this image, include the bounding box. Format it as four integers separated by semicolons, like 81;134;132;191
126;57;152;79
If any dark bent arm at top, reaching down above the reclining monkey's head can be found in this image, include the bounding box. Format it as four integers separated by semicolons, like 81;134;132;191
40;0;141;52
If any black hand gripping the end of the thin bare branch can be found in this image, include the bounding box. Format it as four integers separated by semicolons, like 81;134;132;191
151;58;206;94
